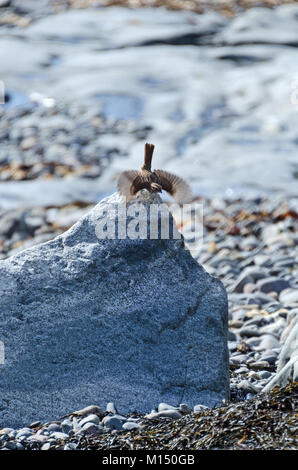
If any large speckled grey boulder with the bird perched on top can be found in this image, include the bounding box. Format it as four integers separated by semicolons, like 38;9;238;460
0;194;229;428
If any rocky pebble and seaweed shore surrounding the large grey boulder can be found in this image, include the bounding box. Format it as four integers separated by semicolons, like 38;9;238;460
0;1;298;450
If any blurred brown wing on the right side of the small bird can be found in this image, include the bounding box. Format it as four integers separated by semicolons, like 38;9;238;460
154;170;194;204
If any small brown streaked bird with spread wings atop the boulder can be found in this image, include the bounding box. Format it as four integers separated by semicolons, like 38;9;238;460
118;144;193;204
